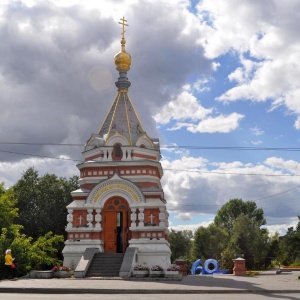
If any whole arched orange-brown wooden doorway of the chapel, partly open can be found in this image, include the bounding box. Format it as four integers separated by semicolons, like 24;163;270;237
103;197;129;253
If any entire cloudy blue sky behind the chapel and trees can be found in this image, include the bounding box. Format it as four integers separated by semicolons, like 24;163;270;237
0;0;300;234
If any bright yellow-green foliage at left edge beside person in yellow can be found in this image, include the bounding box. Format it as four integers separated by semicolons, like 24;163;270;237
0;177;72;279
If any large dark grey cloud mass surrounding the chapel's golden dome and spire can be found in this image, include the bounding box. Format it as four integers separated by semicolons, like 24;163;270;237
0;0;213;161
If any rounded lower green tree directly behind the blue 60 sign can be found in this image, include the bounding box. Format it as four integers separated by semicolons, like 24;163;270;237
193;223;228;260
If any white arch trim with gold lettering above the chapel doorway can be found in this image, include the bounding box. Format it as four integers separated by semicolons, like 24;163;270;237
85;174;145;208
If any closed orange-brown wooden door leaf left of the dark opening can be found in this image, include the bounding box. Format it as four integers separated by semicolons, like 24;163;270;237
104;211;117;253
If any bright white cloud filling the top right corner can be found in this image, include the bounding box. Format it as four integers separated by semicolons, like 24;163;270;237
198;0;300;125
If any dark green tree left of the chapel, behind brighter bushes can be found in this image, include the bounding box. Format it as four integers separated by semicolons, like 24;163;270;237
13;168;78;240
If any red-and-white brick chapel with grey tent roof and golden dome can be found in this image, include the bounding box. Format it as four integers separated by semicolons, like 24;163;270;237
63;17;171;269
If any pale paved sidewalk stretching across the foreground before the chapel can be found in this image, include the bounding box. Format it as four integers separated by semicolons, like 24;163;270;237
0;270;300;297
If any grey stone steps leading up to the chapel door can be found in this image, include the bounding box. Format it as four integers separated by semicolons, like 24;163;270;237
86;253;124;277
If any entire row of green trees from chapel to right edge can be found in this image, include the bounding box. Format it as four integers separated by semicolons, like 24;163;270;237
169;199;300;272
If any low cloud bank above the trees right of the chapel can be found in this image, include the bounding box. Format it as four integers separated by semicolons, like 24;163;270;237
162;152;300;225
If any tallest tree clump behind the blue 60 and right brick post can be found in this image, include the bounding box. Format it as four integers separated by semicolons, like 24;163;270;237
192;199;277;271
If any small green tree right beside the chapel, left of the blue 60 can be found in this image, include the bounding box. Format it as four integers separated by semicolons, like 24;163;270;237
168;229;193;262
